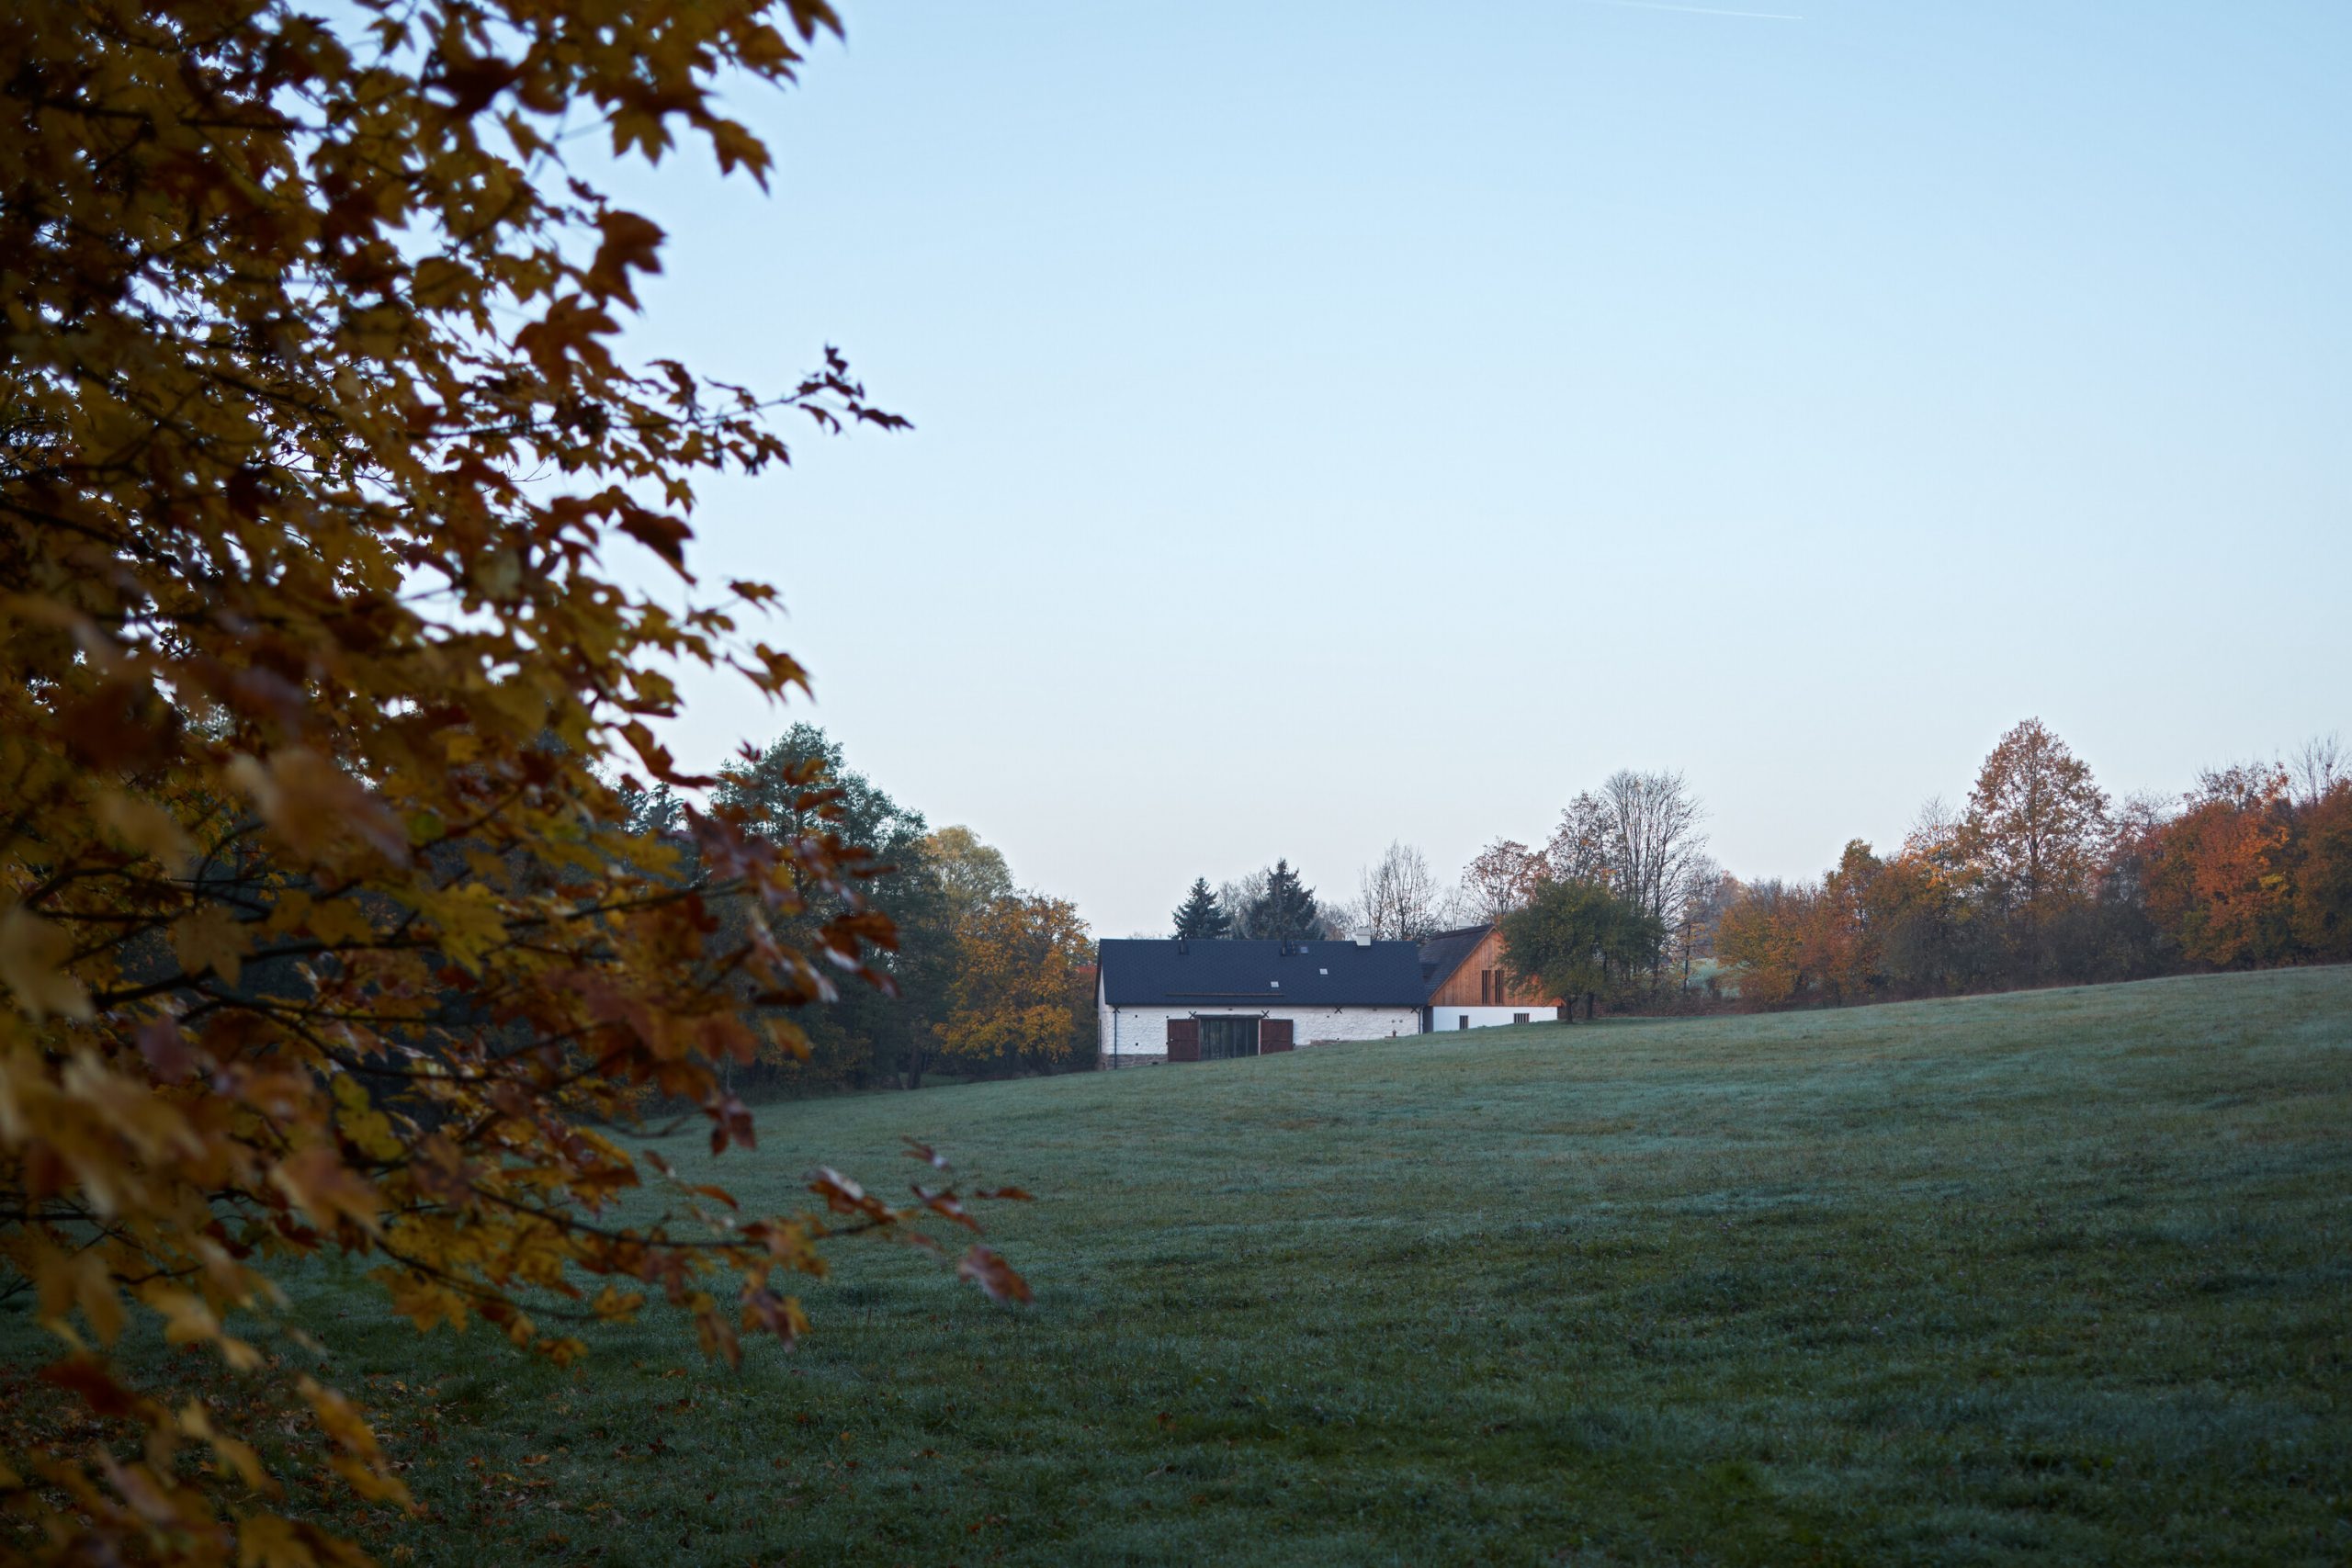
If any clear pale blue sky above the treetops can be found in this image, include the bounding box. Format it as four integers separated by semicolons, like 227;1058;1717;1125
602;0;2352;936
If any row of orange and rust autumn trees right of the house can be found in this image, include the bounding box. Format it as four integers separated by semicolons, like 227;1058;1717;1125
1714;719;2352;1006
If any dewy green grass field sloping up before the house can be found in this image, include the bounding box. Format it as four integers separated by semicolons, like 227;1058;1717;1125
5;968;2352;1565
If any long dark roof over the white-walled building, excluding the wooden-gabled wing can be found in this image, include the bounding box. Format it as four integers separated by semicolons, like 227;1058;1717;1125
1101;938;1425;1006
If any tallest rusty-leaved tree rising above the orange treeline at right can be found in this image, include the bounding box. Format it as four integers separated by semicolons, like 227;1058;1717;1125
1962;719;2108;974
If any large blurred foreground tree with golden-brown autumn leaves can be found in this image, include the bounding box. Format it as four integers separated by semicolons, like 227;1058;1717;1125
0;0;1021;1565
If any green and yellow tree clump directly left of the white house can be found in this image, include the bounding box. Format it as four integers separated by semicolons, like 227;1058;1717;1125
638;724;1096;1093
